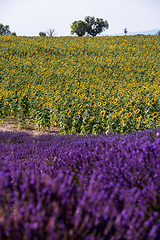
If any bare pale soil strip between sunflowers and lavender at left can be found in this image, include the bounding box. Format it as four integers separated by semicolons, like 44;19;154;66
0;117;60;135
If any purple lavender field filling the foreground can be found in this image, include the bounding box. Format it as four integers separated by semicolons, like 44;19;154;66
0;127;160;240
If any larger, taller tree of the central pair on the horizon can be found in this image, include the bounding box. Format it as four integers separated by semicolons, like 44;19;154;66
84;16;109;37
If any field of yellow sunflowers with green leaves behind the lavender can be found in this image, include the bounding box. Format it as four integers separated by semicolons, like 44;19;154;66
0;35;160;134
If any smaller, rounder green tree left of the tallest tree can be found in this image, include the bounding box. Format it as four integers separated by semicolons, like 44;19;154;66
71;20;87;37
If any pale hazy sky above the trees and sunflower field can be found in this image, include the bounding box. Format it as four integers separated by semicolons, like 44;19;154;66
0;0;160;36
